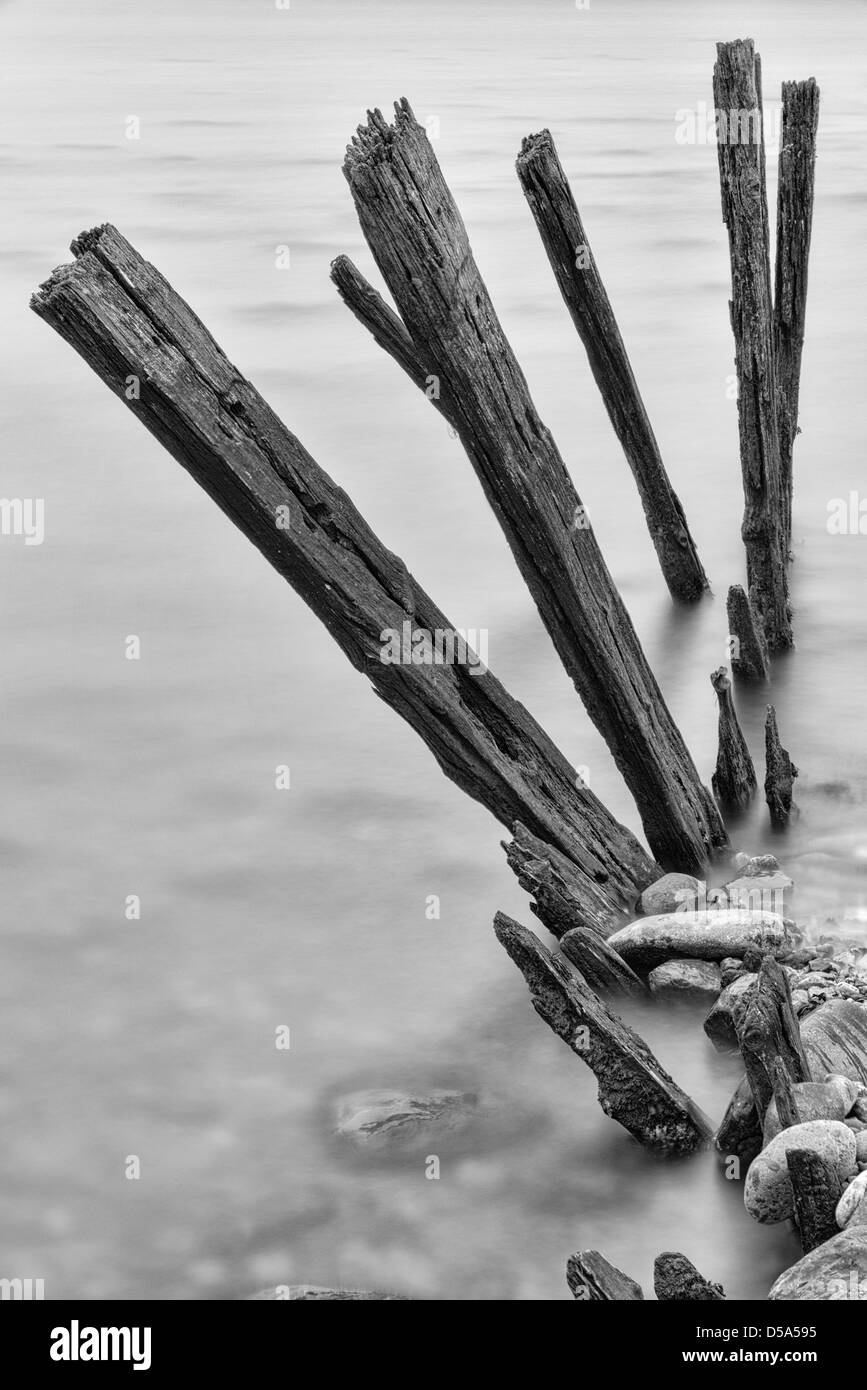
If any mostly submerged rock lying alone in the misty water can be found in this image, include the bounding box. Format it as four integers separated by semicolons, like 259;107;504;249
333;1088;479;1152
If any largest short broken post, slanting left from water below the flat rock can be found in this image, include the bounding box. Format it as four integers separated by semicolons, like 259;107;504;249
493;912;711;1154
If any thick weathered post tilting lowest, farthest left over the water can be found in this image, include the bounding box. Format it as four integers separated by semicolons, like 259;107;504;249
32;227;657;919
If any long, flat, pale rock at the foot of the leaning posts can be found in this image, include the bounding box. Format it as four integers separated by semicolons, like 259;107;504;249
609;910;792;972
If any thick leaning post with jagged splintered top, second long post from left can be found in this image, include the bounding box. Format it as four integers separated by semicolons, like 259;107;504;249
342;100;728;872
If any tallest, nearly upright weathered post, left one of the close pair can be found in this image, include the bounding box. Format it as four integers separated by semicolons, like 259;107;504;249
714;39;792;652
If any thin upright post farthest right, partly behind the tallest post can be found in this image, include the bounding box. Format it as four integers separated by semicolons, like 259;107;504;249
774;78;818;555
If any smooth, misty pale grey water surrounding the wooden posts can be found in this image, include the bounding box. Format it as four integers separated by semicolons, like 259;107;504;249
0;0;867;1300
